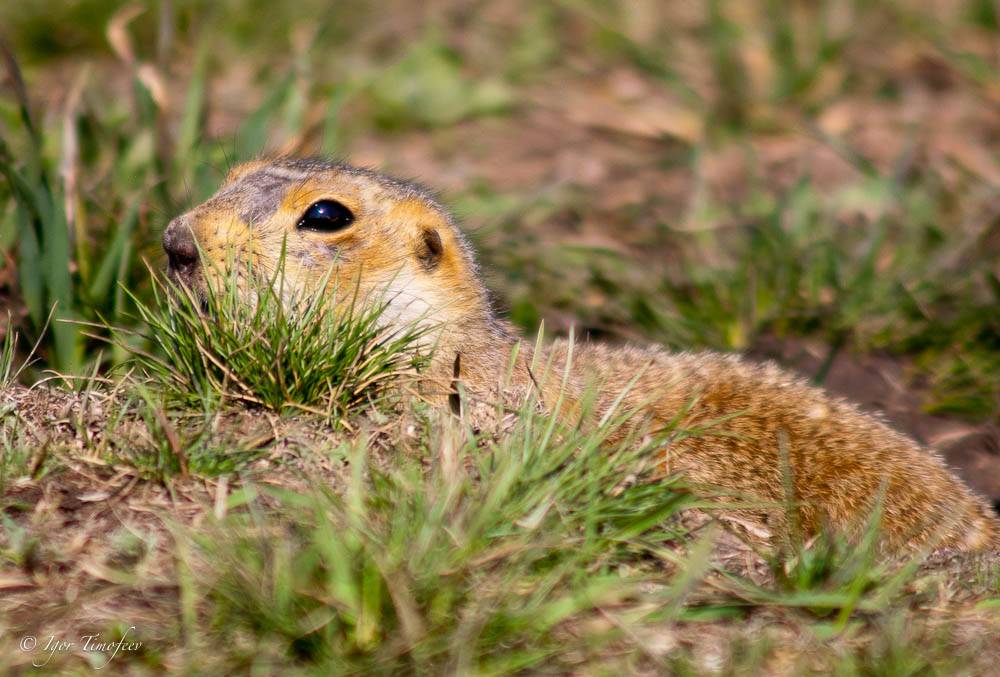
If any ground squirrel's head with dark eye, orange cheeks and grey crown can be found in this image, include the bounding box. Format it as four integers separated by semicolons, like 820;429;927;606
163;159;490;334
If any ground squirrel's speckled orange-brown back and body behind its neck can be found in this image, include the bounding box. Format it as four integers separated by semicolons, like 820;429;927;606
551;342;1000;550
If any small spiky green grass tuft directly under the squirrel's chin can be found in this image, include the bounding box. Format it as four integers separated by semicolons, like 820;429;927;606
120;262;431;420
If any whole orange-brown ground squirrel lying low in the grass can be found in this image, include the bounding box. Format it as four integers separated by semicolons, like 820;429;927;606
163;159;1000;550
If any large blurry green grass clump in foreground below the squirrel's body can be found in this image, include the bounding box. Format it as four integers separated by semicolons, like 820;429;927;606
192;390;706;673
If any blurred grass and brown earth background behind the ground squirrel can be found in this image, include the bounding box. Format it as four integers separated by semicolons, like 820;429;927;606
0;0;1000;498
